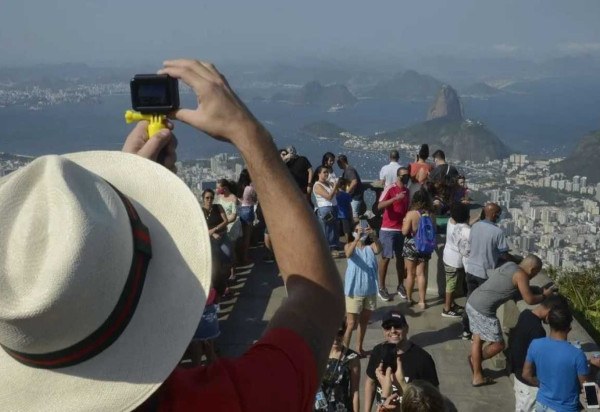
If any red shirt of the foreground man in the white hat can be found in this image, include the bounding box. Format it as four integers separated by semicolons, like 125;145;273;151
139;328;318;412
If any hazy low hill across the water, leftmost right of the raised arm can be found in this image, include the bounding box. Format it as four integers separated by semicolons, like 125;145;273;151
272;82;358;107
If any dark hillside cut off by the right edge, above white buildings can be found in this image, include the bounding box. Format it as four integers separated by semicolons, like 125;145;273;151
551;130;600;184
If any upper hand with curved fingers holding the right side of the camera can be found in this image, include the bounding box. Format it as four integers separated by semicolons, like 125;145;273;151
158;59;266;143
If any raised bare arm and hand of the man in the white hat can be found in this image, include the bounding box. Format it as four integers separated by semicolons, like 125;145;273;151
160;60;344;379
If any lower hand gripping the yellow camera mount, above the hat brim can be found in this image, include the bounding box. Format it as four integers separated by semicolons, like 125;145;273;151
122;120;177;173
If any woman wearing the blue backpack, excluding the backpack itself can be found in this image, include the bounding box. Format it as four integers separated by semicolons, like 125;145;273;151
402;188;435;309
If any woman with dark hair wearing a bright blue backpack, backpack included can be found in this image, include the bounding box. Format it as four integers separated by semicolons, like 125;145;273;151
402;188;436;309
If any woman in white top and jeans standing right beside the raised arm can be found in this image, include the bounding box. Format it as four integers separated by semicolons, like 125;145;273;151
313;166;339;257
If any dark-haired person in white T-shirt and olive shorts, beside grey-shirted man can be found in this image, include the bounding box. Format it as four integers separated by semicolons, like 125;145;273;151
442;202;471;318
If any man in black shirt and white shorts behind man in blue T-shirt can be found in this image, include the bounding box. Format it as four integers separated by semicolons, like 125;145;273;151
508;295;569;412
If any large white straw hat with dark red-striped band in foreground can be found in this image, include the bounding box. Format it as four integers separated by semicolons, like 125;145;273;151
0;152;211;411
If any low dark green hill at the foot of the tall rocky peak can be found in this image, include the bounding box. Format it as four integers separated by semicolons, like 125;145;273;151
377;118;511;162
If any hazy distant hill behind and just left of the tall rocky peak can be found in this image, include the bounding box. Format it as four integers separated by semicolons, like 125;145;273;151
368;70;442;100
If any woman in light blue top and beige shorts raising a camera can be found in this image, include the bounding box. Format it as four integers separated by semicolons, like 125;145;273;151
344;224;382;357
